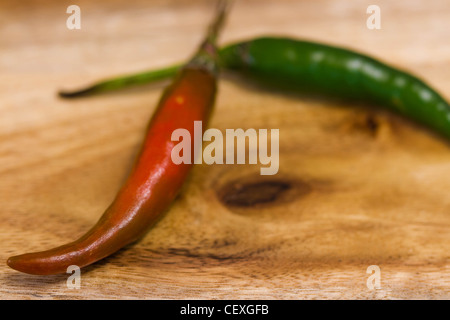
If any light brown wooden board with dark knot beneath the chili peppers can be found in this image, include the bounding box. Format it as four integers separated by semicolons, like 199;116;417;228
0;0;450;299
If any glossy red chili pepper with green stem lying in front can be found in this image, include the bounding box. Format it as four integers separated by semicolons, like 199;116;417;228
8;2;226;275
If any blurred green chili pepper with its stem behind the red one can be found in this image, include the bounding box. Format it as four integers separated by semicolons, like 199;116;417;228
59;37;450;138
